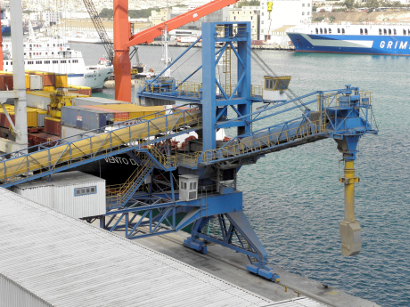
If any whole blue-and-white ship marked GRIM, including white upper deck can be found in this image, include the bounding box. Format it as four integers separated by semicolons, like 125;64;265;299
286;23;410;56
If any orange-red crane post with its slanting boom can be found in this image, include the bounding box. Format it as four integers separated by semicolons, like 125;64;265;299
113;0;239;102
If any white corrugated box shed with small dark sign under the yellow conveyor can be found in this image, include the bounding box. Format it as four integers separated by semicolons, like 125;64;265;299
14;171;106;218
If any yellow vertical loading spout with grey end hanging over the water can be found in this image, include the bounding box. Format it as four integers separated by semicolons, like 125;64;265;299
340;161;362;256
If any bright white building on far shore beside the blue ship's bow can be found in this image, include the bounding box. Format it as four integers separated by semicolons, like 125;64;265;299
260;0;312;40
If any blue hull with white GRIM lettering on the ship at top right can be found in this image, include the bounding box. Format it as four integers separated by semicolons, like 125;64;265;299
287;33;410;56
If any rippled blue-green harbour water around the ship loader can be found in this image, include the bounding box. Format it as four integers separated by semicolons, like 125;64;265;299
72;44;410;306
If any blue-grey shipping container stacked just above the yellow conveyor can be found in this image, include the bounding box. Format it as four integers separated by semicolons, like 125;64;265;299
61;106;114;130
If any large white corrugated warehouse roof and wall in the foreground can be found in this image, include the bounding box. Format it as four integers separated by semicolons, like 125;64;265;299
0;188;319;307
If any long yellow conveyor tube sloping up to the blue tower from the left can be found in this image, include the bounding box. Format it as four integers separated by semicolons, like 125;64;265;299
0;109;202;182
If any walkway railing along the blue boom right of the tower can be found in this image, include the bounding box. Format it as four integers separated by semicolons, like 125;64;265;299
202;121;321;163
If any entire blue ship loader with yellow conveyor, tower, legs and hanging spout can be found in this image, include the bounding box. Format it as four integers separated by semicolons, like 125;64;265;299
0;22;377;281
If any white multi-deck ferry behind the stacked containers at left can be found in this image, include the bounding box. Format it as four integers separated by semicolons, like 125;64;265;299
2;38;114;91
